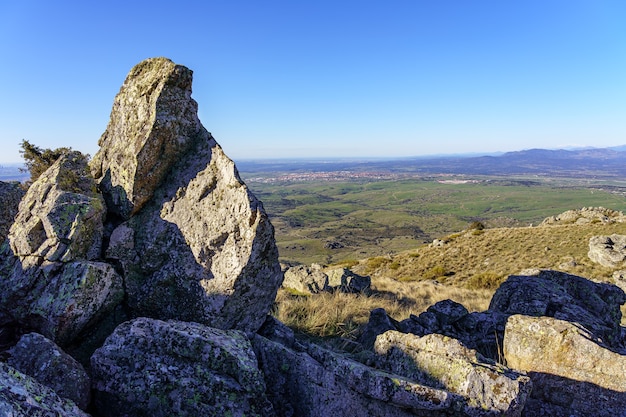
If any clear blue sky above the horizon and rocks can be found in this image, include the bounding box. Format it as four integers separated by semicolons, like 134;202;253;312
0;0;626;162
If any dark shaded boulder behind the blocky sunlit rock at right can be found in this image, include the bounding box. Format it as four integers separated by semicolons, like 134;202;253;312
489;270;626;347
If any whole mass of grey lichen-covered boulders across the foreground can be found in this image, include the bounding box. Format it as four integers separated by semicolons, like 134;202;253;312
0;58;626;417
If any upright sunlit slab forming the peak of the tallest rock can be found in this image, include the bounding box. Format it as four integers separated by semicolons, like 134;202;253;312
90;58;201;218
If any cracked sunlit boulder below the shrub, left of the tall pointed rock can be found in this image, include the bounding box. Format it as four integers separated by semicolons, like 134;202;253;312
8;152;106;262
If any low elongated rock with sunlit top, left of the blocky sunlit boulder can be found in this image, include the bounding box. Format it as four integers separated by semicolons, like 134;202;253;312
374;330;531;416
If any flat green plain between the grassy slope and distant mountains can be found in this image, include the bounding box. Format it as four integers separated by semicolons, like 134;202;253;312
242;173;626;264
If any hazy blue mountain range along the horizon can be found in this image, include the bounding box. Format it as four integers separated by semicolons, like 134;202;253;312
0;145;626;181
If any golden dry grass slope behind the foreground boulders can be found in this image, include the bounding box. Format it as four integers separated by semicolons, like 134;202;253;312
274;219;626;338
